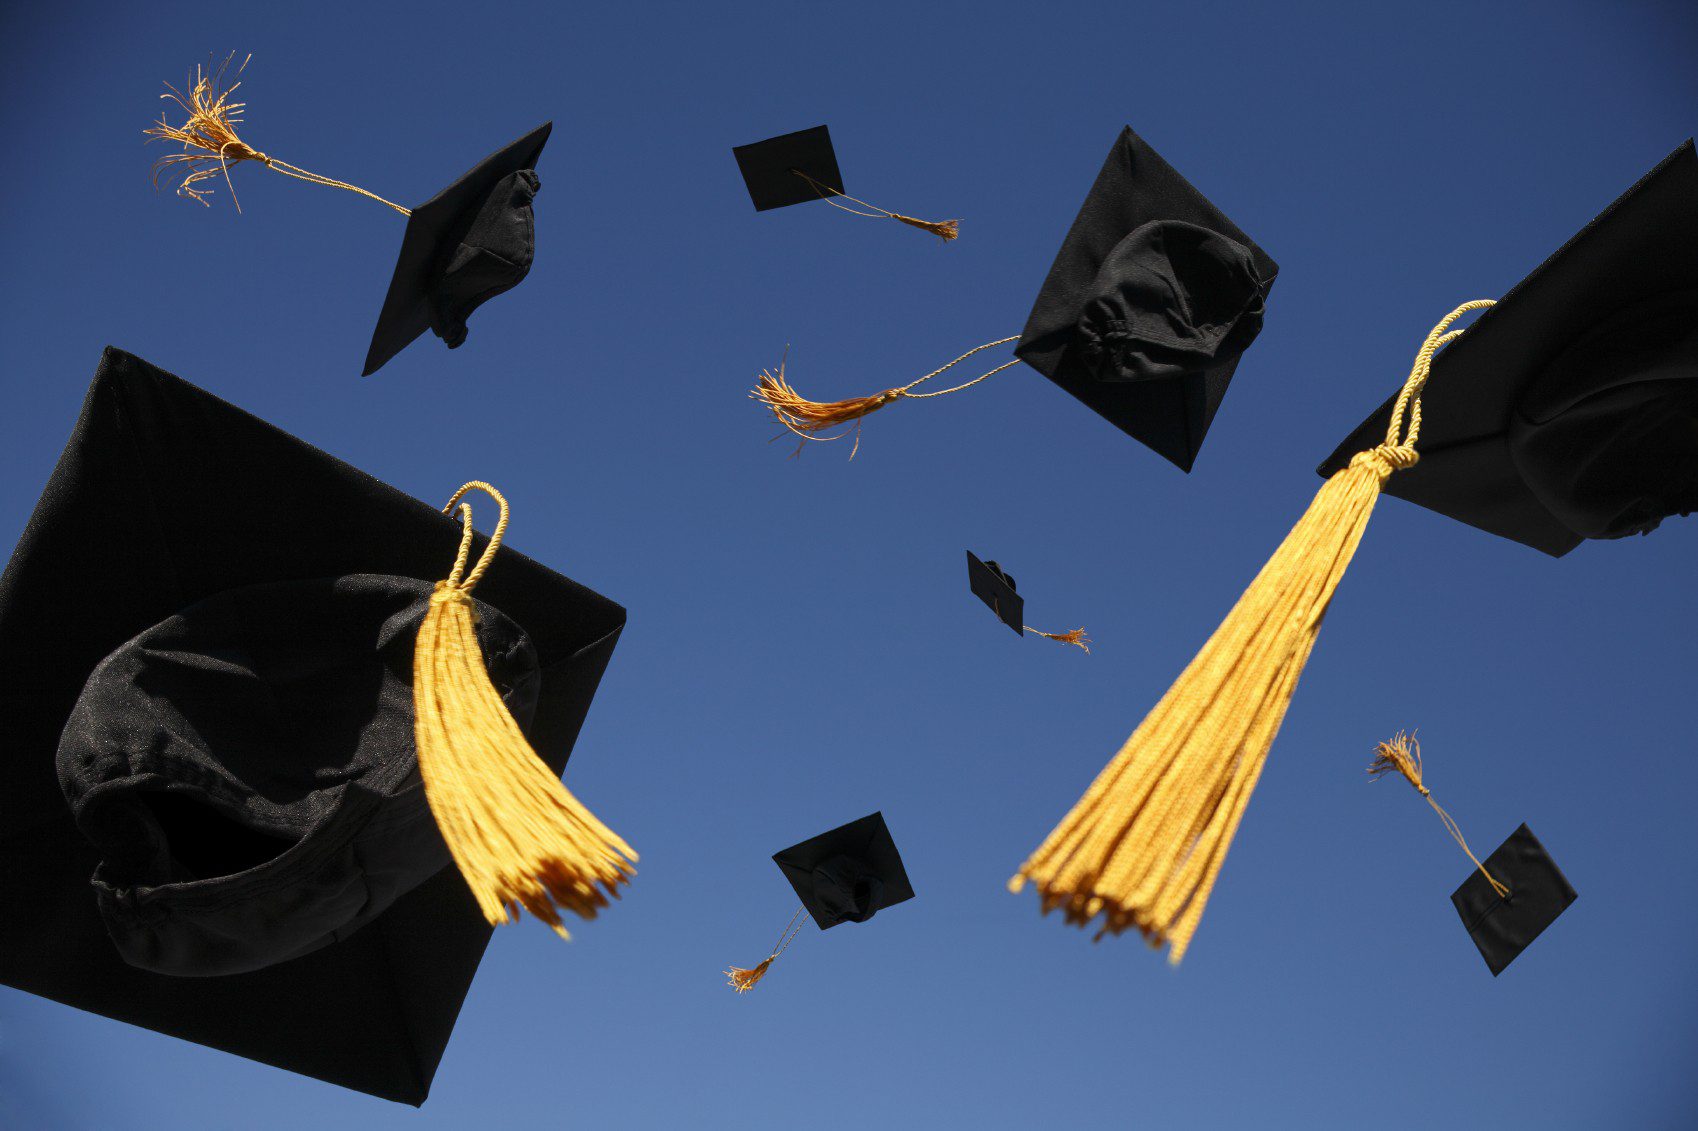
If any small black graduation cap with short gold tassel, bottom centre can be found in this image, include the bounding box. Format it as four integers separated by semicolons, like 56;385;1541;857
725;812;914;993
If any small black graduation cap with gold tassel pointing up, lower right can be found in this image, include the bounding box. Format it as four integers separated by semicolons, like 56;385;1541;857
1369;732;1577;978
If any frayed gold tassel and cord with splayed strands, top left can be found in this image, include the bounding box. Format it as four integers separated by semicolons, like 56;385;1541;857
141;53;413;216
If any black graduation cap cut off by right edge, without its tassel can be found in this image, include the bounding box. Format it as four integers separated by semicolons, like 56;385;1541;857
1319;139;1698;557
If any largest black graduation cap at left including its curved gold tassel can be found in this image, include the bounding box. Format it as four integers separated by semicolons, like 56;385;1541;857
0;348;625;1104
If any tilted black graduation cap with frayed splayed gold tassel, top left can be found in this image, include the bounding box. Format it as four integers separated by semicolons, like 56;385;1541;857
143;56;554;377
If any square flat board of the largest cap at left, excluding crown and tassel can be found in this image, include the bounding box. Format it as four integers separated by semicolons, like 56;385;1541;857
0;350;625;1104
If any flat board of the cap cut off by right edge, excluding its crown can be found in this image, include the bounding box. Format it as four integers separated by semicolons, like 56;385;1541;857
1316;139;1698;557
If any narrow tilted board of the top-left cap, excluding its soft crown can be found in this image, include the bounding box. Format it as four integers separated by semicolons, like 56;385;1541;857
360;122;554;377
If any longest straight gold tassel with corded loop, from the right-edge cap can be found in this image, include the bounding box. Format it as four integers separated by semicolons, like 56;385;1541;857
1009;299;1491;965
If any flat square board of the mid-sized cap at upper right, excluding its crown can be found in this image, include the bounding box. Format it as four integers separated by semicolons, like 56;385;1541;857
1014;126;1279;470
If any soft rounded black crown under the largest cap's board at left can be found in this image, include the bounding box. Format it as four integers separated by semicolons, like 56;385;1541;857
58;574;538;976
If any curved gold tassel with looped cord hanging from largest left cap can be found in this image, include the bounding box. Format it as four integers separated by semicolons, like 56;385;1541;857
413;482;637;939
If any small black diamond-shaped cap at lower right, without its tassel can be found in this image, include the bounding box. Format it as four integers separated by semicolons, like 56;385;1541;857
1450;825;1579;978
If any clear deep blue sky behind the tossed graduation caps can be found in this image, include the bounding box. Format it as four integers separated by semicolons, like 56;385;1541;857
0;0;1698;1131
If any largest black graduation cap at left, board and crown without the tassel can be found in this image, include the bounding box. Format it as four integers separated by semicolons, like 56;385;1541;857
0;350;625;1104
